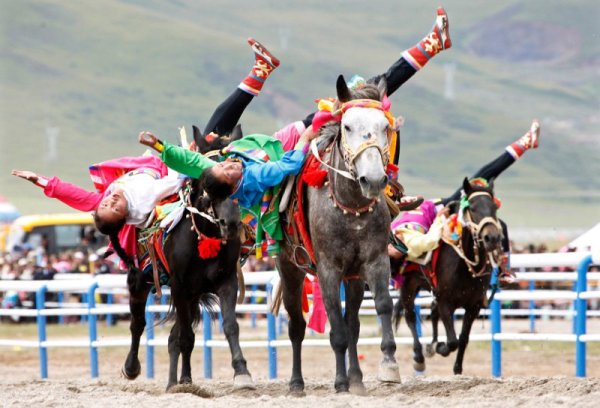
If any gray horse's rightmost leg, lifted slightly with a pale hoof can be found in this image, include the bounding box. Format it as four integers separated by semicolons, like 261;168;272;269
364;257;400;382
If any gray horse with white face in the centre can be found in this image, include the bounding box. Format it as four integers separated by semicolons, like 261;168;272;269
278;76;400;395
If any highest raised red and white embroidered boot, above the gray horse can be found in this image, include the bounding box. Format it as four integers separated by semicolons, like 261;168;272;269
402;7;452;71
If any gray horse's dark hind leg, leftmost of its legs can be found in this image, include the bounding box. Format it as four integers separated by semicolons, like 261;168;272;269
278;256;306;397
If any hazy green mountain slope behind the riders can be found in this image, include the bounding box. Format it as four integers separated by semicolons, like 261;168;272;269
0;0;600;228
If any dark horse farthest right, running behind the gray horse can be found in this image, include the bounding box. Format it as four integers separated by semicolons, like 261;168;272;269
392;178;502;374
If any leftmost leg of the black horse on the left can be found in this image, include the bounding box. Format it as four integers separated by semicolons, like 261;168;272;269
121;287;150;380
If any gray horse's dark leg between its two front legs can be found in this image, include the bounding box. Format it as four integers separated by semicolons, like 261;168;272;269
344;279;367;395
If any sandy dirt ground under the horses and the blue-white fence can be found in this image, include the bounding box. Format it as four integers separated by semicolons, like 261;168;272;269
0;319;600;408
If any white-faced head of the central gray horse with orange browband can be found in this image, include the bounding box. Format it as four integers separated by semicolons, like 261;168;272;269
336;75;393;199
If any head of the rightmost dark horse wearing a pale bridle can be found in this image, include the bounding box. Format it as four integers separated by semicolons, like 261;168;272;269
460;177;502;252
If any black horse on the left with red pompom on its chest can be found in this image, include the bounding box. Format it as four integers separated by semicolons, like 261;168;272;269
122;180;252;389
